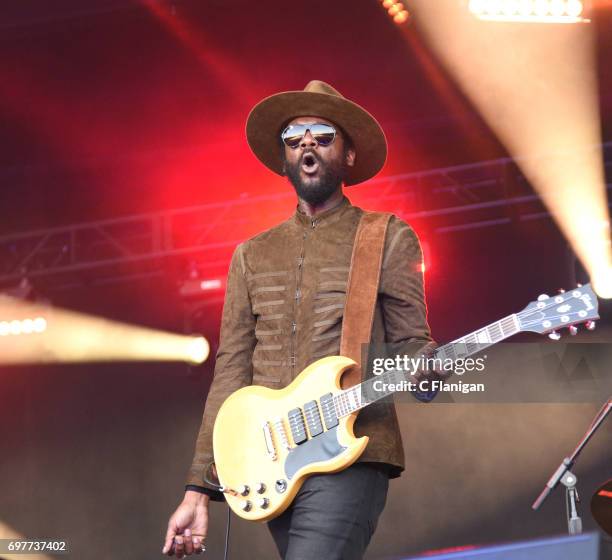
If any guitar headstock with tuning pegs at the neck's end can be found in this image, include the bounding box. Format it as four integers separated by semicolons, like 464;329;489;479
516;284;599;340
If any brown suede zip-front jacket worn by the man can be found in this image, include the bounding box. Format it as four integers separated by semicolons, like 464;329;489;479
187;197;431;487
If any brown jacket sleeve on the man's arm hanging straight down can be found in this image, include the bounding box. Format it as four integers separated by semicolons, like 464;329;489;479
186;244;255;488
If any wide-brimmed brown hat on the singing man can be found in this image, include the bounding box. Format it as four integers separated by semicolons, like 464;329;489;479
246;80;387;185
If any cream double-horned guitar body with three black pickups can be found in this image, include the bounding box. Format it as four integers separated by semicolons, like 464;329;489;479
213;356;369;521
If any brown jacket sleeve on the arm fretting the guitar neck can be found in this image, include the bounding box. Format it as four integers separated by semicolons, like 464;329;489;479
380;216;447;402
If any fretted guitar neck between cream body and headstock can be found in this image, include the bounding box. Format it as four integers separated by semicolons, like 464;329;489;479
334;314;521;417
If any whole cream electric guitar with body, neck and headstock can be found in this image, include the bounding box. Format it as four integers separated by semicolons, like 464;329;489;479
213;285;599;521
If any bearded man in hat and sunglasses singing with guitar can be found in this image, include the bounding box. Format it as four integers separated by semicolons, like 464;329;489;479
163;80;431;560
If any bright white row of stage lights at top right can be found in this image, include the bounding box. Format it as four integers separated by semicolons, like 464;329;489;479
468;0;591;23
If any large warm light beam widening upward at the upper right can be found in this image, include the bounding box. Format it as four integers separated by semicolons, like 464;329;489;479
413;0;612;297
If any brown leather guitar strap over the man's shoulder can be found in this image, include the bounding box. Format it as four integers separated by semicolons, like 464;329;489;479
340;212;391;388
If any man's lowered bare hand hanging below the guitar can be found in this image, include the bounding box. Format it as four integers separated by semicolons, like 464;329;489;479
162;490;210;558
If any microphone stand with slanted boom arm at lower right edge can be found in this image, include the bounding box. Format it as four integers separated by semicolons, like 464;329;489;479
531;397;612;535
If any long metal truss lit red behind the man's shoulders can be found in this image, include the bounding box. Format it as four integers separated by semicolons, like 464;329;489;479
0;142;612;285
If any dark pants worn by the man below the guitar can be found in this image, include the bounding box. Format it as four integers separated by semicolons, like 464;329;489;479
268;463;389;560
